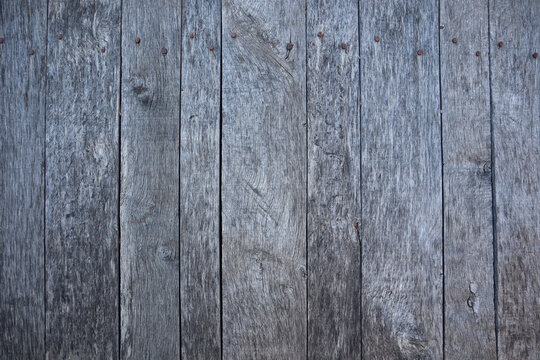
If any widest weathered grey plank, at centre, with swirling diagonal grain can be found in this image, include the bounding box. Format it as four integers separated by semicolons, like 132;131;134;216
222;0;307;359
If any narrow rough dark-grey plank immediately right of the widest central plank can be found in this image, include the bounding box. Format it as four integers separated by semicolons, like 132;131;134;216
307;0;362;359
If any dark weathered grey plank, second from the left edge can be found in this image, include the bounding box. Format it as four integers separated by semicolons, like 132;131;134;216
45;0;120;359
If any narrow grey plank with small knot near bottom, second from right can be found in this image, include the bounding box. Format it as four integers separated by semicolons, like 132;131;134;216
440;0;496;360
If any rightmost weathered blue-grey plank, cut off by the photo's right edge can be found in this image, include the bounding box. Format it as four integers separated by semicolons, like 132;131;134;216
490;0;540;359
